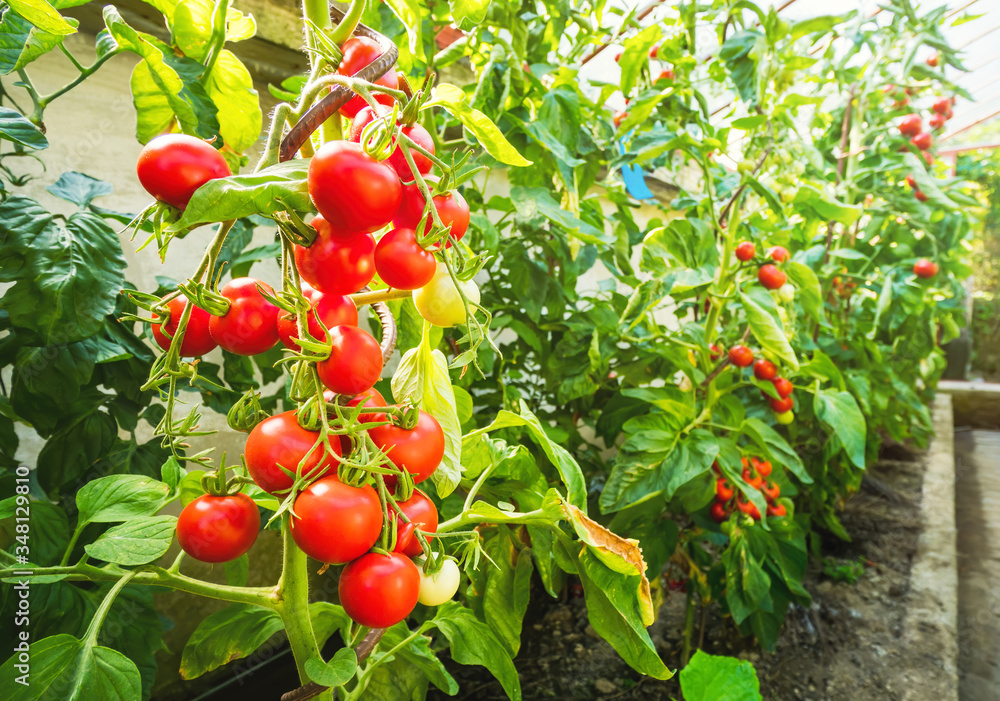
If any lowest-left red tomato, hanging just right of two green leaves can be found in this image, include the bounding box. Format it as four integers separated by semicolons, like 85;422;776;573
177;494;260;562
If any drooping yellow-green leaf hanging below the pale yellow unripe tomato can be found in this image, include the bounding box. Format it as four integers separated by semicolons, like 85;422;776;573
389;323;462;498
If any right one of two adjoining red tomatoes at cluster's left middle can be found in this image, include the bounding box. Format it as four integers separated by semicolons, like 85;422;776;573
208;277;280;355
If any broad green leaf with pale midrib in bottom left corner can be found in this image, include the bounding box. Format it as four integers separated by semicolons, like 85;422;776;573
0;635;142;701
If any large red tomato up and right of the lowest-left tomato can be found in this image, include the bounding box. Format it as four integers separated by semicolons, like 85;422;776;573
243;411;341;494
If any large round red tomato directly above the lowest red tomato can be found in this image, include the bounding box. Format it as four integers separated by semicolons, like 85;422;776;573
291;475;382;565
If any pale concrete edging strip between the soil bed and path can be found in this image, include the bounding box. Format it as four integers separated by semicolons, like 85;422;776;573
897;393;958;701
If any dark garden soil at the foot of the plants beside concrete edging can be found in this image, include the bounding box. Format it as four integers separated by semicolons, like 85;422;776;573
429;447;936;701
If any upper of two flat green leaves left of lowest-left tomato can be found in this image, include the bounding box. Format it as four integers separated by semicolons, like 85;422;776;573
76;475;170;524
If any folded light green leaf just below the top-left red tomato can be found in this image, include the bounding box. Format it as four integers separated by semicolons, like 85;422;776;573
167;159;312;233
